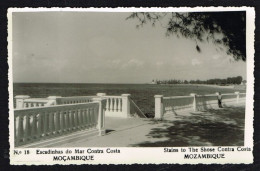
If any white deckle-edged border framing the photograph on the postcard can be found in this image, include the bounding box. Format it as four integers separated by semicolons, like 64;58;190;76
7;7;255;165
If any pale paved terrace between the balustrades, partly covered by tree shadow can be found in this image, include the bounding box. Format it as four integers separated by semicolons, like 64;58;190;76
35;103;245;147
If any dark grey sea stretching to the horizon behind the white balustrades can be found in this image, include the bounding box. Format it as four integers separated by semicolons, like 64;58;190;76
13;83;245;115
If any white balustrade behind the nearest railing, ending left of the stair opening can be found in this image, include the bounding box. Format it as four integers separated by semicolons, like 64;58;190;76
15;93;145;118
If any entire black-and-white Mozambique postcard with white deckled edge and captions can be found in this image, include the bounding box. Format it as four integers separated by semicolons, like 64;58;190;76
8;7;254;164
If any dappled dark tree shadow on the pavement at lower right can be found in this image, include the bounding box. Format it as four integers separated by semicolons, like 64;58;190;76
133;107;245;147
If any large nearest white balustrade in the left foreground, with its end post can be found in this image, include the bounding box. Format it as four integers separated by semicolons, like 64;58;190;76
14;100;105;146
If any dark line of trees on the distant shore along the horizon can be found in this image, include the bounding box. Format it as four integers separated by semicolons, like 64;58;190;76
152;76;246;85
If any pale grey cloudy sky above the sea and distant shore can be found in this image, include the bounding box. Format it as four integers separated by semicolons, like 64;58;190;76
12;12;246;83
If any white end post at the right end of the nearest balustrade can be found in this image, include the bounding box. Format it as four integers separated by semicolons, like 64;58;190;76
93;98;106;136
